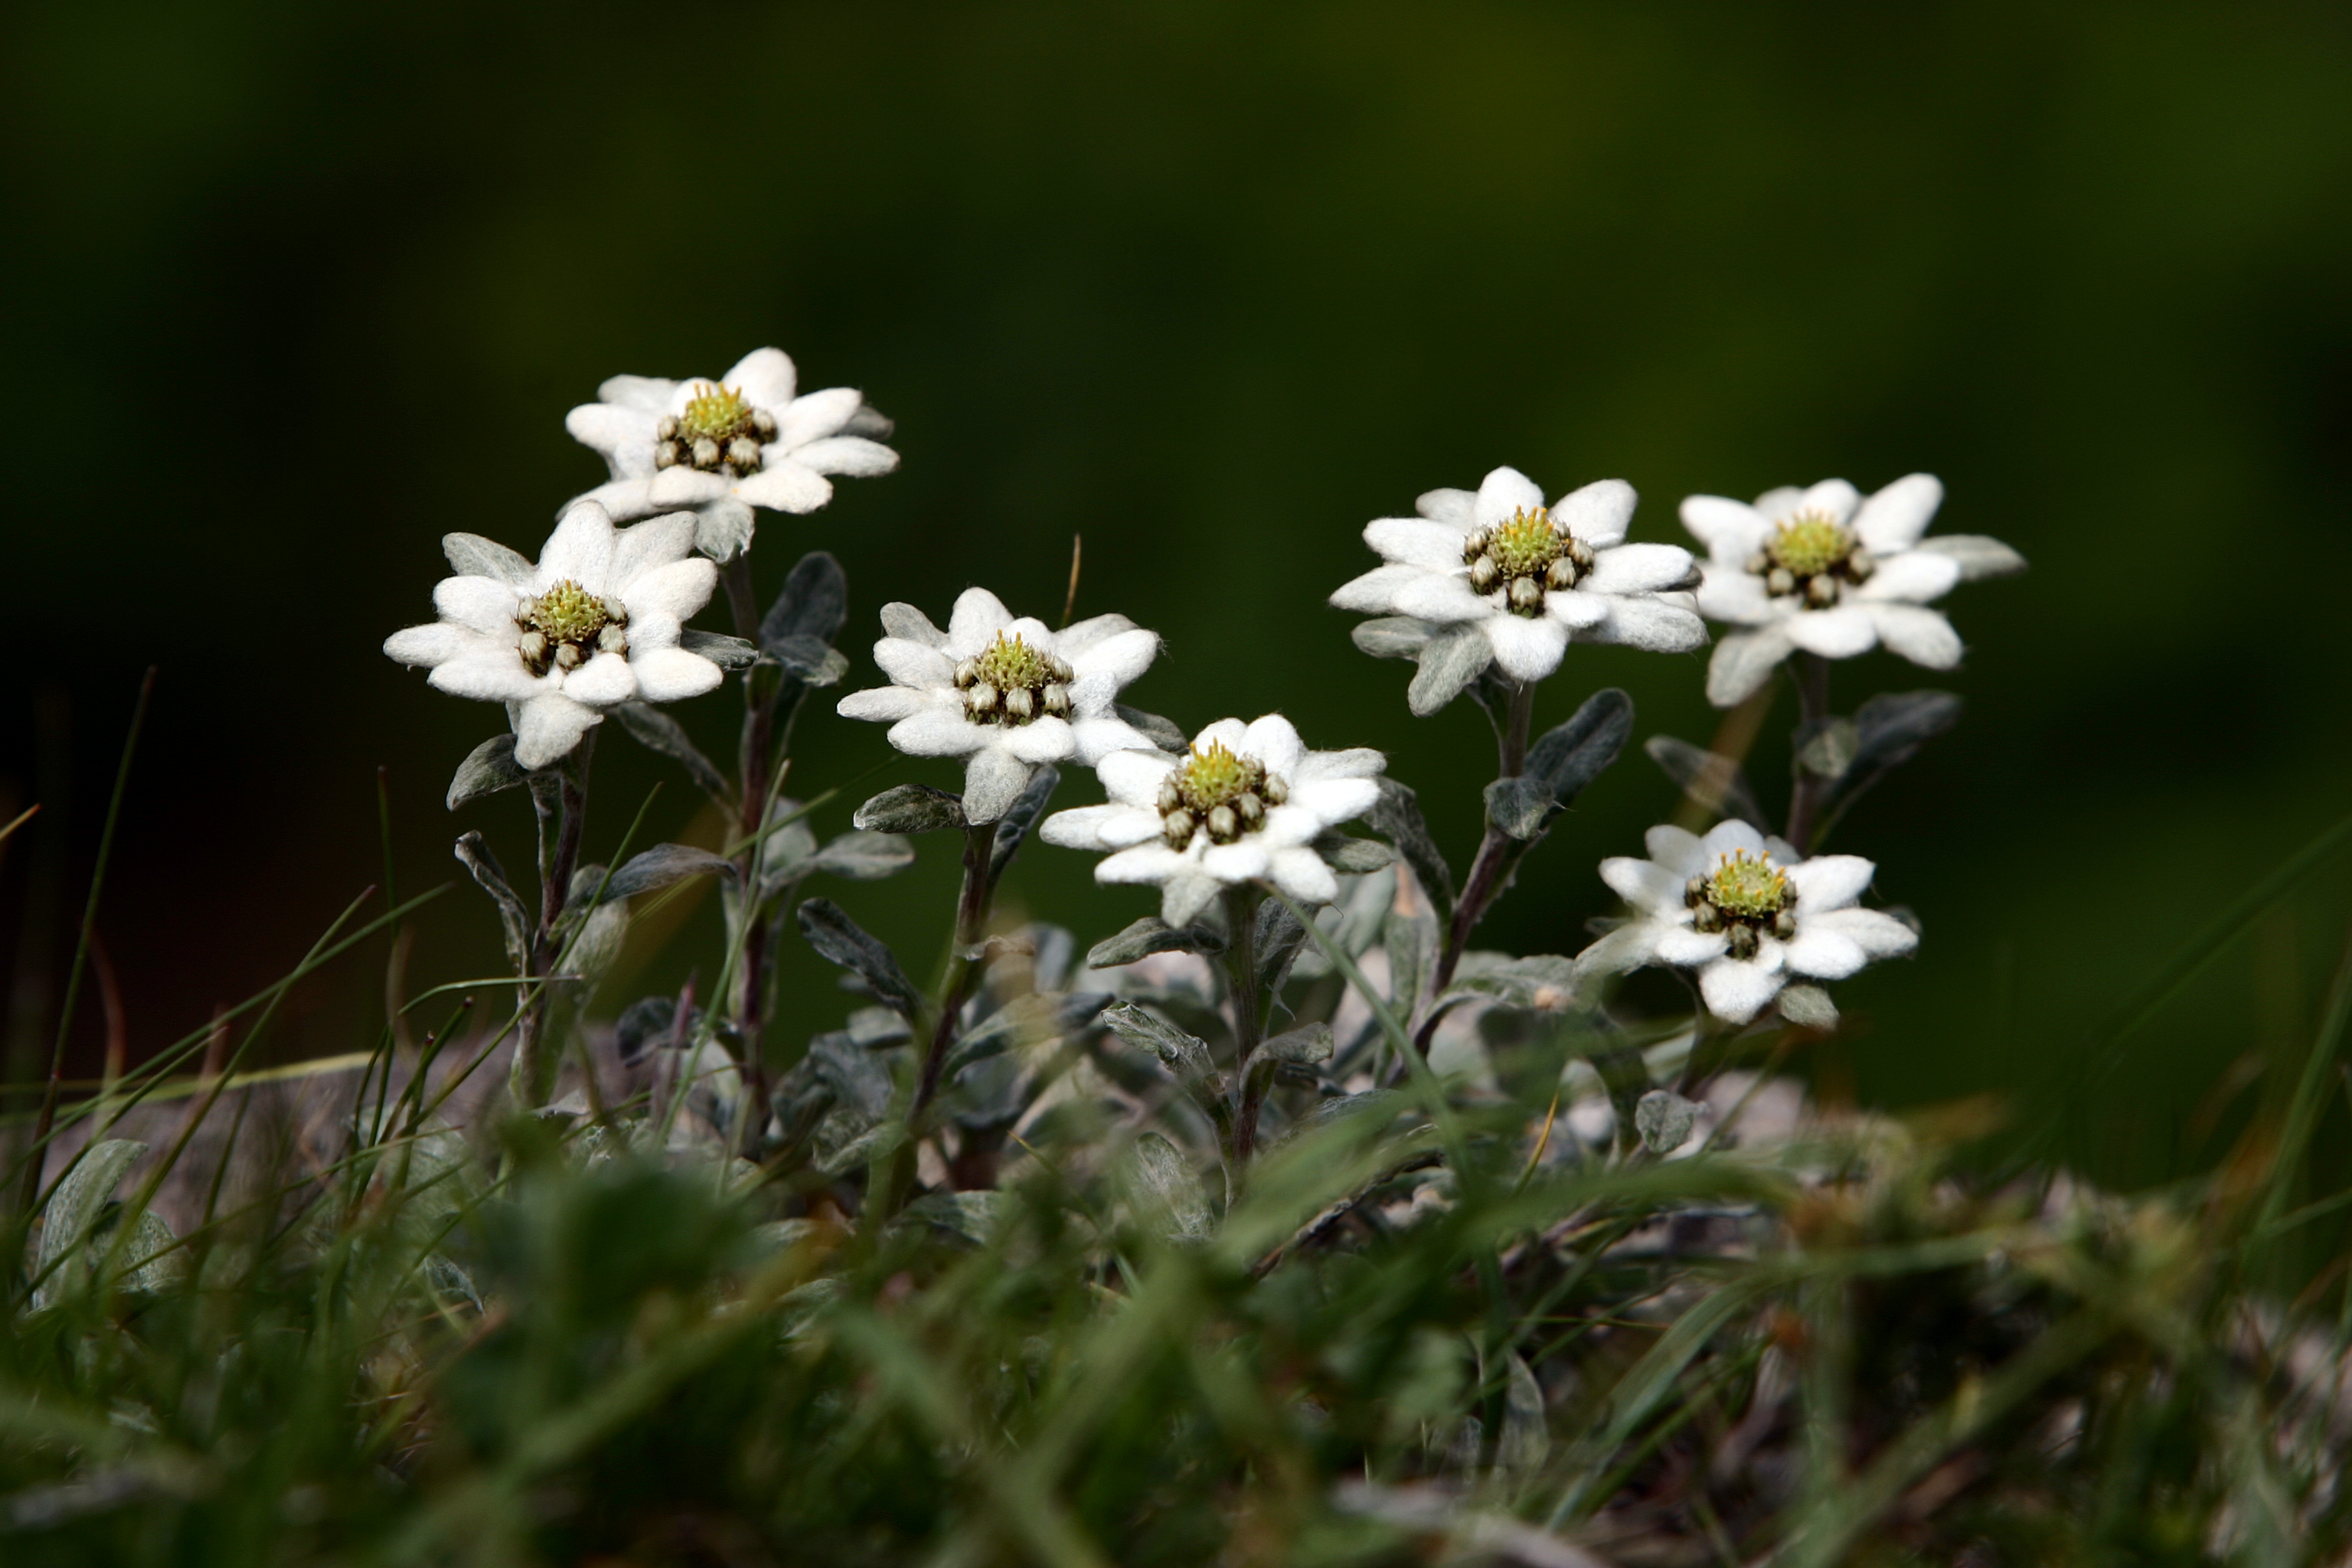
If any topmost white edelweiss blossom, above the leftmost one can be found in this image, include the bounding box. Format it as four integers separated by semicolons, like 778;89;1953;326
564;348;899;560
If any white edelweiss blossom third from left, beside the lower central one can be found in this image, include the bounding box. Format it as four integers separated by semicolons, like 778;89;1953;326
840;588;1159;823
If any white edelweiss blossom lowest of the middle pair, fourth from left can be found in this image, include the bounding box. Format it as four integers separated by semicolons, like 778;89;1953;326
1037;714;1387;926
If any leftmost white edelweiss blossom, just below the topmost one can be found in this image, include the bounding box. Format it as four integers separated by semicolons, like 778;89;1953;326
384;501;724;769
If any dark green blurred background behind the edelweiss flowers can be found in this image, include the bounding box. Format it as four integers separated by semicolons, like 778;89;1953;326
0;0;2352;1180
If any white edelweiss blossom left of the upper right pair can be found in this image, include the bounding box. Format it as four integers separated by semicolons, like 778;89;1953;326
1331;468;1707;681
